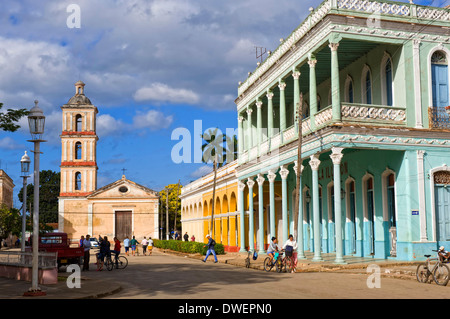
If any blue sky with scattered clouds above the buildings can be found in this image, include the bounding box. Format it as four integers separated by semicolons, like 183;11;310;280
0;0;449;207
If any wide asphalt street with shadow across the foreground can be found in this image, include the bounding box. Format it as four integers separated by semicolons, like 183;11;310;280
83;252;450;300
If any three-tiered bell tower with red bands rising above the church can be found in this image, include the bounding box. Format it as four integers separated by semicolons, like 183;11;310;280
60;81;98;197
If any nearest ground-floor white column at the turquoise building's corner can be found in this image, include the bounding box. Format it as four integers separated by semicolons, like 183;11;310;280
330;147;346;264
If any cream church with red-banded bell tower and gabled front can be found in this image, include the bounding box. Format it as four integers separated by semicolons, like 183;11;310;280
58;81;159;244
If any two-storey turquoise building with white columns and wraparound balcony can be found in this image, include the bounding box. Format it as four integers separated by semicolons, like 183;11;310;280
235;0;450;263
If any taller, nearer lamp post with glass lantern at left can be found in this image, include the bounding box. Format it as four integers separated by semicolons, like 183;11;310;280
25;100;46;296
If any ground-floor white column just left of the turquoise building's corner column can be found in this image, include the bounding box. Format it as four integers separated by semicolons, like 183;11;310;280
309;154;323;261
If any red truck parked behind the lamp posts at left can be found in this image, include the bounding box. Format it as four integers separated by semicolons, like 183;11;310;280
27;233;84;268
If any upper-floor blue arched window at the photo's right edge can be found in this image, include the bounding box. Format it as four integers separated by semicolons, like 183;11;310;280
431;51;449;107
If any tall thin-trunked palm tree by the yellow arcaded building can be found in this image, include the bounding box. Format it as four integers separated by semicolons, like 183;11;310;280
202;128;237;236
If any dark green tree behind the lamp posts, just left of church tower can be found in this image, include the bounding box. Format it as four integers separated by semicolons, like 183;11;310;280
18;170;61;223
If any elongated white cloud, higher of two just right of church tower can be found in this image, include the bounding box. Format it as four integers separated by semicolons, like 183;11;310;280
133;83;200;104
